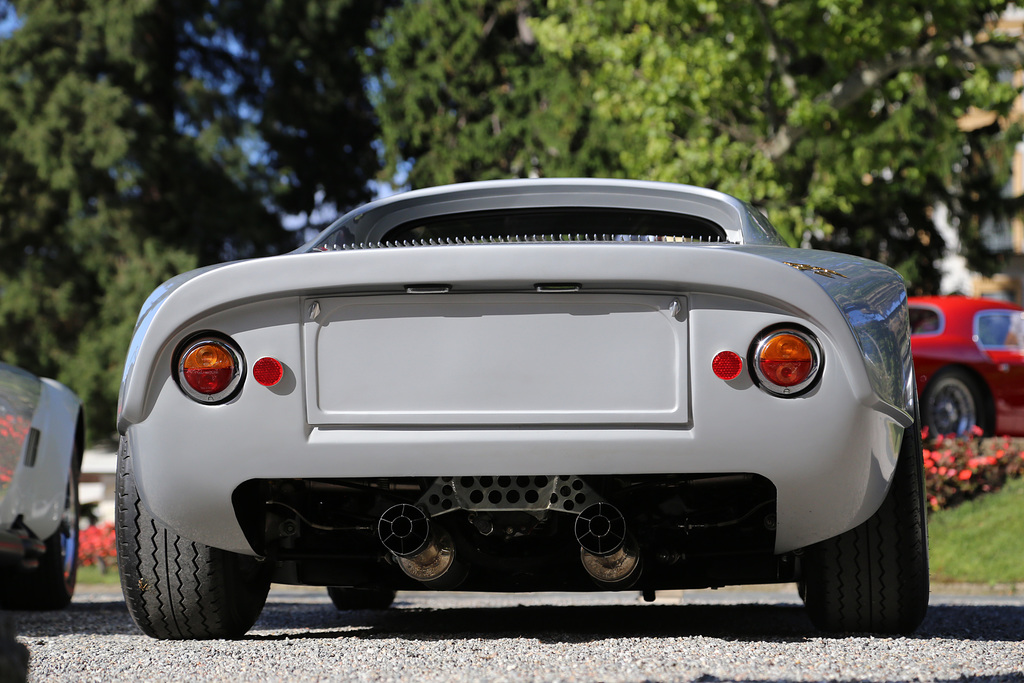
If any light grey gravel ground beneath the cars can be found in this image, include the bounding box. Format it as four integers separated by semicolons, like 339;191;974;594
12;587;1024;683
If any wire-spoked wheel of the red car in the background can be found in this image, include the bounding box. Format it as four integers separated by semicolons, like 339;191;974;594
922;368;990;436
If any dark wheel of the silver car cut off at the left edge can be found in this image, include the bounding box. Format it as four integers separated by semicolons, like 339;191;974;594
0;454;79;609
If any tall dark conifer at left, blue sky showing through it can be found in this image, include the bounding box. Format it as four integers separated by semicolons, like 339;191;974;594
0;0;378;436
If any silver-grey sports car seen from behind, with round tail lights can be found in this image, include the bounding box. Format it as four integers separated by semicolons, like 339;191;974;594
118;179;929;638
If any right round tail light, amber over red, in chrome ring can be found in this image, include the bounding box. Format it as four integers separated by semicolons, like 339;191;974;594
754;330;821;395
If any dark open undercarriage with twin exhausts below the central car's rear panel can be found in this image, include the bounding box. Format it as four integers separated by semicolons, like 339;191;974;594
232;474;797;595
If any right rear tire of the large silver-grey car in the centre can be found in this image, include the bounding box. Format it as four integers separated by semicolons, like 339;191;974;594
800;409;929;634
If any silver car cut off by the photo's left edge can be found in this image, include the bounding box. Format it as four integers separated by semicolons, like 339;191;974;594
0;362;85;609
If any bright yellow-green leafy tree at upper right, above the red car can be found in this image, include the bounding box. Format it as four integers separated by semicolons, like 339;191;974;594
534;0;1024;291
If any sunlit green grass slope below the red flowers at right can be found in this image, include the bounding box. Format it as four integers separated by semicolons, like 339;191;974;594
928;479;1024;584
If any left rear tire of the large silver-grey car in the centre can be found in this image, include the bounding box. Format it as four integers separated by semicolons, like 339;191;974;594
116;439;270;640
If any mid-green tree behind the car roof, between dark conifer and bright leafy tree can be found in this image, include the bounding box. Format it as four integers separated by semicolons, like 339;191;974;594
365;0;622;187
